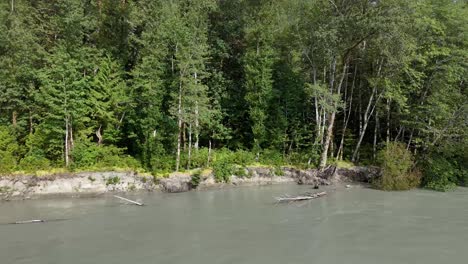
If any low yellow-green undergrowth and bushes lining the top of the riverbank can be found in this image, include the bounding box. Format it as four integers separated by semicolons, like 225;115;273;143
0;143;468;191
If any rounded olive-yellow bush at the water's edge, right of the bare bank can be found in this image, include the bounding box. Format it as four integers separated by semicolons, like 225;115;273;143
374;142;421;191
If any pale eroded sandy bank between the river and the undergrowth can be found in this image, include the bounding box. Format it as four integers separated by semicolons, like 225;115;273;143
0;167;378;200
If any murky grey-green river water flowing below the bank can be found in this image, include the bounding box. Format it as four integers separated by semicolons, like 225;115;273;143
0;185;468;264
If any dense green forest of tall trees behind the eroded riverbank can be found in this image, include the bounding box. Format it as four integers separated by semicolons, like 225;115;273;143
0;0;468;189
